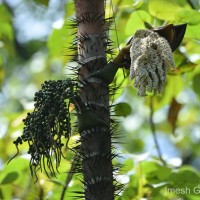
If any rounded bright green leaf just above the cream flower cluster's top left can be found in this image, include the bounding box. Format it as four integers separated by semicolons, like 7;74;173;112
125;10;151;36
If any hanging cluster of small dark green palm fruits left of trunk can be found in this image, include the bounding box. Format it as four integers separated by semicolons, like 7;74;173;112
13;79;78;175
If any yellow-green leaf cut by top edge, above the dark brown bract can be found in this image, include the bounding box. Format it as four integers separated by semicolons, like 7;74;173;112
149;0;181;21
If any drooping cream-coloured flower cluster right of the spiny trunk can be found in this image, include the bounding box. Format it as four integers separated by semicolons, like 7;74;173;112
130;30;175;96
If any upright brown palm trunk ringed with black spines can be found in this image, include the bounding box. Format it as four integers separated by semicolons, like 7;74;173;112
75;0;114;200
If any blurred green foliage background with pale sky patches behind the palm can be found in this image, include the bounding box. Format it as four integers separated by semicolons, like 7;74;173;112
0;0;200;200
